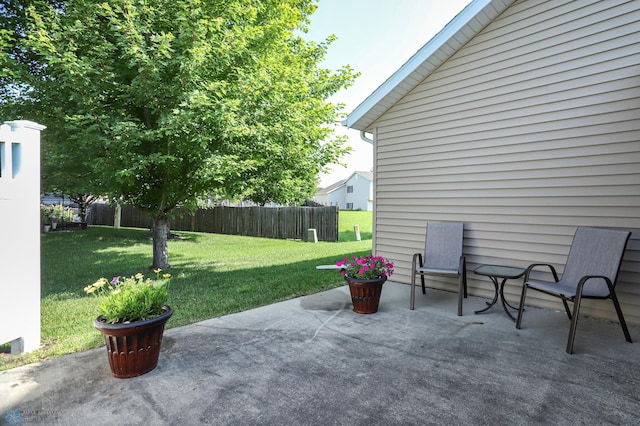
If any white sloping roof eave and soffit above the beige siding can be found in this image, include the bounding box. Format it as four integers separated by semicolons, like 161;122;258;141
342;0;515;131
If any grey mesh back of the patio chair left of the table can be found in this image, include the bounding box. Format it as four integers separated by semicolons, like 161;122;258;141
424;222;464;270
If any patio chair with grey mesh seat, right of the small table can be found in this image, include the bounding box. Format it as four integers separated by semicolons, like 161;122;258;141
516;227;631;353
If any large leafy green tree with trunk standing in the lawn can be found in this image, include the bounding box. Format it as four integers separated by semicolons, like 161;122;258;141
0;0;355;268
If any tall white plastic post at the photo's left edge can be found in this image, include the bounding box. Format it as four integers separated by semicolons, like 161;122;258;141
0;121;45;354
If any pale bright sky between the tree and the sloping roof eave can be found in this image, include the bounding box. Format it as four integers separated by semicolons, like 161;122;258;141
304;0;471;187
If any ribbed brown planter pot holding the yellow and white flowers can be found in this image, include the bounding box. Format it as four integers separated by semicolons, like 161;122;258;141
93;306;173;379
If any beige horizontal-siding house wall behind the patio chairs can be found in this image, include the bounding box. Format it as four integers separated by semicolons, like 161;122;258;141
373;0;640;322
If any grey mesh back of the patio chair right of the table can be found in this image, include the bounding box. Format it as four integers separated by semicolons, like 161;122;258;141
560;227;631;297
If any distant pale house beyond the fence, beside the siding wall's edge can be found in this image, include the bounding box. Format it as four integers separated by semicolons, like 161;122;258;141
315;171;373;211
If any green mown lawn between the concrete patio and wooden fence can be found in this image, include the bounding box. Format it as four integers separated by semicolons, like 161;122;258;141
0;211;372;370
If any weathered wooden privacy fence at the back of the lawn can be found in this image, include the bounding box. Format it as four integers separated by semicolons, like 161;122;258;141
87;204;338;241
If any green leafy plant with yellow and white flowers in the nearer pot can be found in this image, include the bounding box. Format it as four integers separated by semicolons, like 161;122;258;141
84;269;171;324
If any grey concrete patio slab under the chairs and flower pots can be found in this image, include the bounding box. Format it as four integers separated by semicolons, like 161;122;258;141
0;282;640;425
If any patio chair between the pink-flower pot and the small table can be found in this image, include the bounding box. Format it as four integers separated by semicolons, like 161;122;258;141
409;222;467;316
